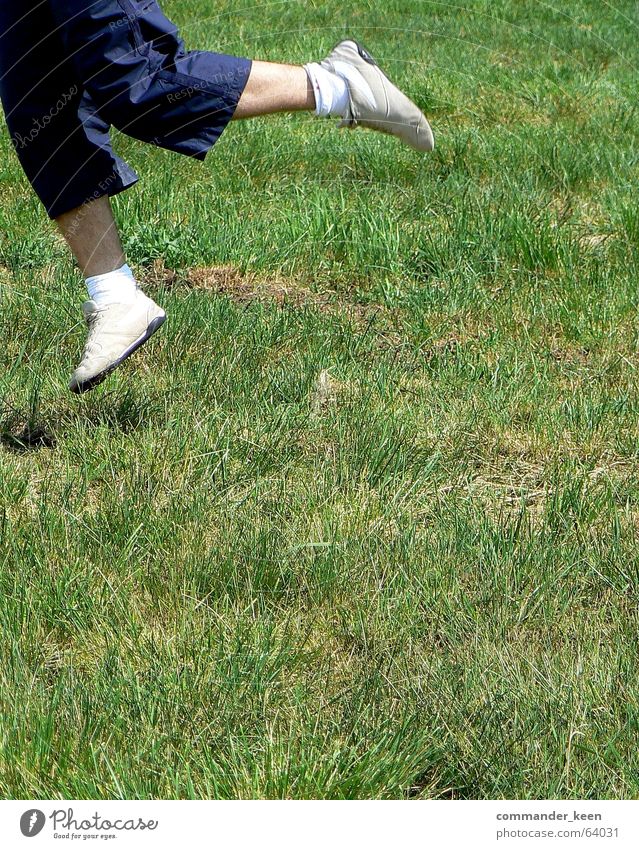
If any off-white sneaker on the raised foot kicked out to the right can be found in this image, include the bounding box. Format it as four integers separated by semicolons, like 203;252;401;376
320;39;435;153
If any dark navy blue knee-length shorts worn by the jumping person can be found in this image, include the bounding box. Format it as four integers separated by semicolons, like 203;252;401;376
0;0;251;218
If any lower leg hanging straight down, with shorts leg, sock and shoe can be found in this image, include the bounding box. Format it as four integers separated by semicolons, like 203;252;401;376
0;0;165;391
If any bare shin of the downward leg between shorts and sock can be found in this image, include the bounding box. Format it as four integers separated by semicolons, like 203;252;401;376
56;197;126;277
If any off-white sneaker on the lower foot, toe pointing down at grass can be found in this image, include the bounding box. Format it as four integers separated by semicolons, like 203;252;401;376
69;289;166;394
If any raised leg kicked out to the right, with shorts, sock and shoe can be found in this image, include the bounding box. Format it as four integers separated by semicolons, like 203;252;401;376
49;0;432;159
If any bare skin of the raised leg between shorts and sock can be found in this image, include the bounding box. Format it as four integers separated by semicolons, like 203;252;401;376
233;62;315;120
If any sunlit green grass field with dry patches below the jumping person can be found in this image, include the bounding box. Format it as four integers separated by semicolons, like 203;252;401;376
0;0;639;798
